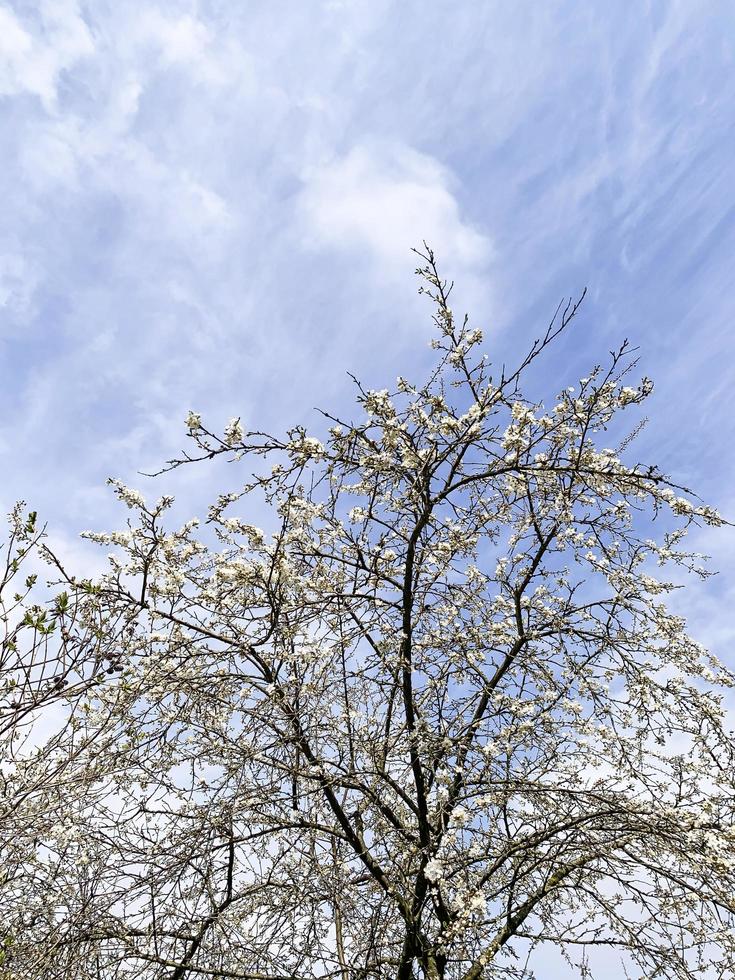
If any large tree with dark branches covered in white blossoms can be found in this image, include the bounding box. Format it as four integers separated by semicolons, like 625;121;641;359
4;250;735;980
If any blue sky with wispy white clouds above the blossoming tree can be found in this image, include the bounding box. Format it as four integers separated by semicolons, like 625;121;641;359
0;0;735;975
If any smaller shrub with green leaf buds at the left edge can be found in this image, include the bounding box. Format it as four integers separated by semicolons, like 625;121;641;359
0;502;119;977
